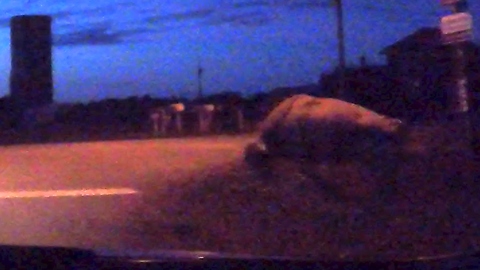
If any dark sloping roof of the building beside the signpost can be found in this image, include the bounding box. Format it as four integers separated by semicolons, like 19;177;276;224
380;27;478;55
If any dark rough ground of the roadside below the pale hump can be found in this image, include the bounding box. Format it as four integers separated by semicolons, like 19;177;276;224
129;124;480;258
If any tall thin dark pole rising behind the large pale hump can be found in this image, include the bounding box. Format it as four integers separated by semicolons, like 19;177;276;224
334;0;345;99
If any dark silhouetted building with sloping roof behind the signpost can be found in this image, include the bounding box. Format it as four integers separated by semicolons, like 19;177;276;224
380;27;480;112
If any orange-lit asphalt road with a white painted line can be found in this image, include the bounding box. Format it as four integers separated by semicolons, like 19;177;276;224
0;137;255;253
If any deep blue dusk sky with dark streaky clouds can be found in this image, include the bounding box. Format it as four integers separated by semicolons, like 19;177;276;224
0;0;480;102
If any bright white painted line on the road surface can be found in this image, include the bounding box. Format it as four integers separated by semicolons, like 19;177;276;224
0;188;138;199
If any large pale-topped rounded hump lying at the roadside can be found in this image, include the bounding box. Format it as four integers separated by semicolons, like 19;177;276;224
245;94;408;161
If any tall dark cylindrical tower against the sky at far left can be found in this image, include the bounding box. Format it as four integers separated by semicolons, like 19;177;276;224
10;15;53;111
